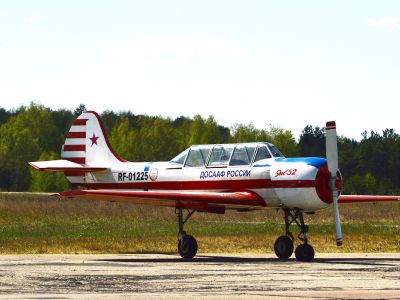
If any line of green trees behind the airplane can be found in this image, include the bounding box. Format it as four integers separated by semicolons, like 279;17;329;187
0;103;400;195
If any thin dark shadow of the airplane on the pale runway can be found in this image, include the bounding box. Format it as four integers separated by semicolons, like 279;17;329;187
97;252;400;266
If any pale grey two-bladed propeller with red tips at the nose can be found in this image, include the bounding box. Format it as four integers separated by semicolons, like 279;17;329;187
326;121;343;246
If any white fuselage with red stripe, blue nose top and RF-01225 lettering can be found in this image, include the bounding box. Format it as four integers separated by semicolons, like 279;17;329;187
68;158;330;211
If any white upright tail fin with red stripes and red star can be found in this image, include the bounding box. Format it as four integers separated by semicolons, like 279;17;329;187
61;111;125;167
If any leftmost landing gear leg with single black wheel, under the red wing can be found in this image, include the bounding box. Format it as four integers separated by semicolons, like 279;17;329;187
177;207;197;259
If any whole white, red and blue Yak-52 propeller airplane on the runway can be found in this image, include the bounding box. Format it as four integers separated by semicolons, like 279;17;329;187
29;111;400;262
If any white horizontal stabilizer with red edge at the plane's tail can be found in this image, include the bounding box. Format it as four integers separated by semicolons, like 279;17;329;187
29;159;108;172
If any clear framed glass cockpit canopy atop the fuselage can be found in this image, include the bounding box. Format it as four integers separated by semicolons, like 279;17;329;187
170;143;284;167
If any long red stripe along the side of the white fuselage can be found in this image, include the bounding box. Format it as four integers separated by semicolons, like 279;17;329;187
79;179;315;190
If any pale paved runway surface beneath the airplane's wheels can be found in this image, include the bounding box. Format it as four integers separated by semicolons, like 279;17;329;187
0;253;400;299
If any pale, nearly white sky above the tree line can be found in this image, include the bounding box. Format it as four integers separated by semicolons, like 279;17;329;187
0;0;400;140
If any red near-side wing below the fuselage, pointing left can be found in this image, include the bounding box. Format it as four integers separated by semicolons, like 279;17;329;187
55;190;266;213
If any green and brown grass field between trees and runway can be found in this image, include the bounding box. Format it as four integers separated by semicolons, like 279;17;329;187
0;193;400;253
